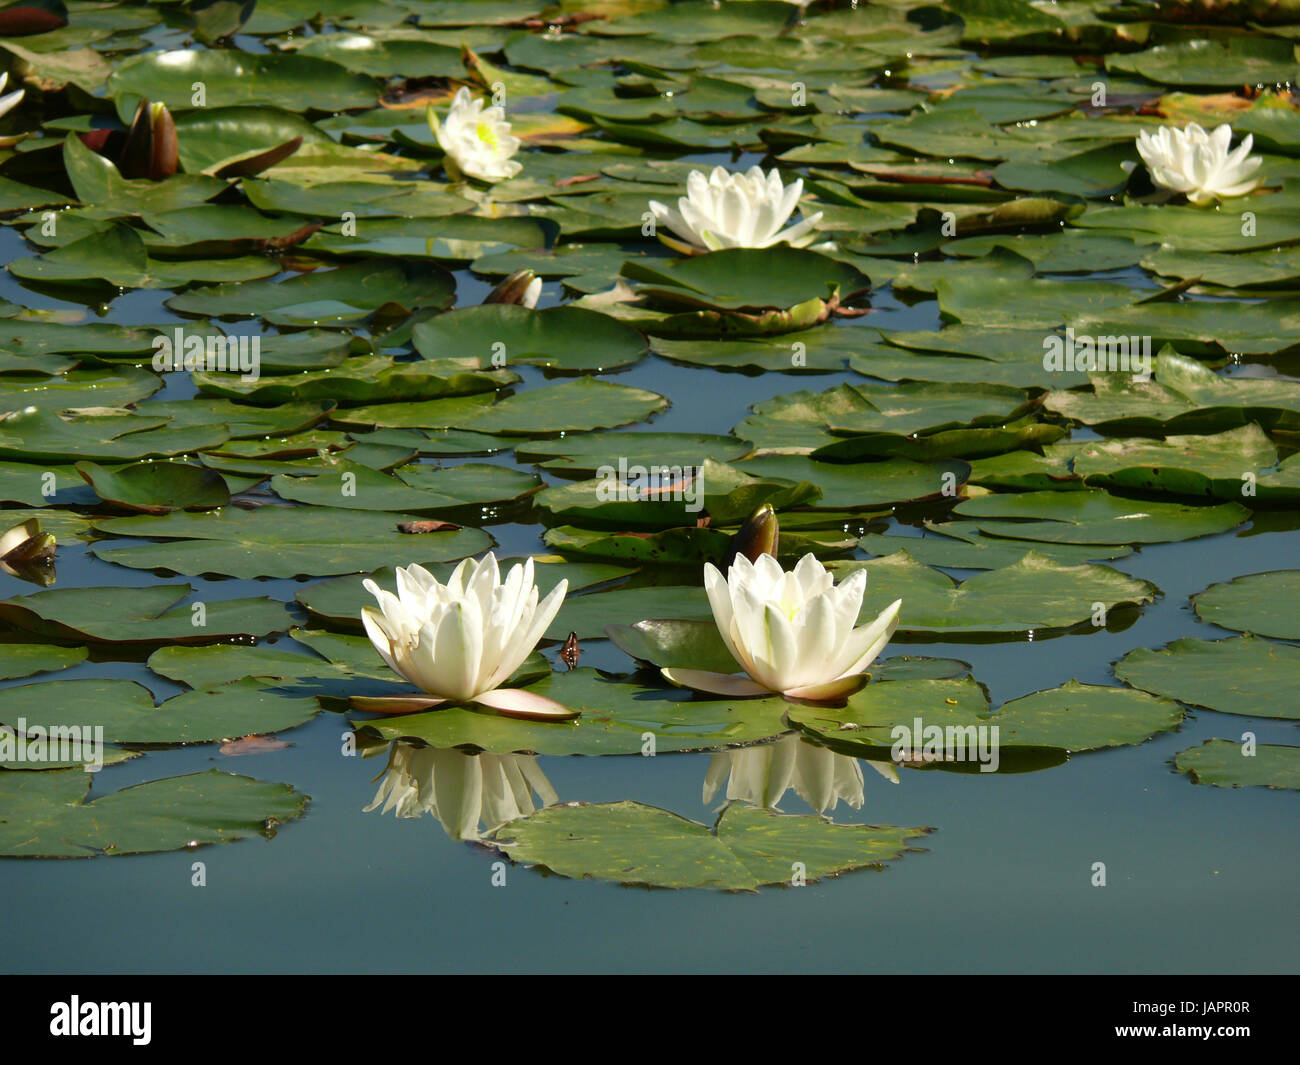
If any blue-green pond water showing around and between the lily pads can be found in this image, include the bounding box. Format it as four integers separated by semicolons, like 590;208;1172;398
0;0;1300;973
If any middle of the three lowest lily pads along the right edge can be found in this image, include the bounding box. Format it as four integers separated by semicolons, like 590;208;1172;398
1115;636;1300;720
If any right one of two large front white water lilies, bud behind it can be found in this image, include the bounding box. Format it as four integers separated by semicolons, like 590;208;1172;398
663;554;902;702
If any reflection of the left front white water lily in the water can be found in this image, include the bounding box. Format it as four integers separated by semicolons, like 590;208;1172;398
365;741;559;840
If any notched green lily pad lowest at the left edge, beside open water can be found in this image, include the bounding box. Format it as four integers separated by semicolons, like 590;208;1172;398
0;770;308;858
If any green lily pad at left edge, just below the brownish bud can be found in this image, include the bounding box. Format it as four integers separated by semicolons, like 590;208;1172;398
0;587;293;644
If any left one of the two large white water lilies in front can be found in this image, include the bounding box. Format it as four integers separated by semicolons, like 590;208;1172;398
361;551;575;718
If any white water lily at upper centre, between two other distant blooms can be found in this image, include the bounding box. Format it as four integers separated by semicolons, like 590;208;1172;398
650;166;822;254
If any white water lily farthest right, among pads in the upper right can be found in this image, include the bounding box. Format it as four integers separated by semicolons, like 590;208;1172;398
1128;122;1264;204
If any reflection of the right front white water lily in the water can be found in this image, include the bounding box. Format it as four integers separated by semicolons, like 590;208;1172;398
705;736;898;814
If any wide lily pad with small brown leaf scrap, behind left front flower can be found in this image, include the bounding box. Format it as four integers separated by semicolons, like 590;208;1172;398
86;507;493;579
